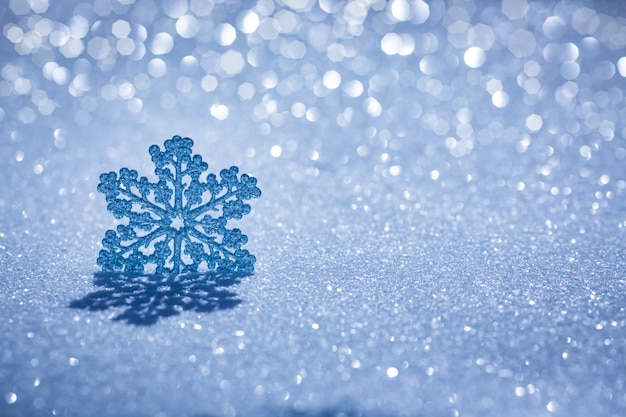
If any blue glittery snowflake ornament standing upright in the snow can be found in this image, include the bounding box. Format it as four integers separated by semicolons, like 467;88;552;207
97;136;261;274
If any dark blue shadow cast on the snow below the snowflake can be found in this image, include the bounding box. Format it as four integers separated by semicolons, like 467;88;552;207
69;272;244;326
